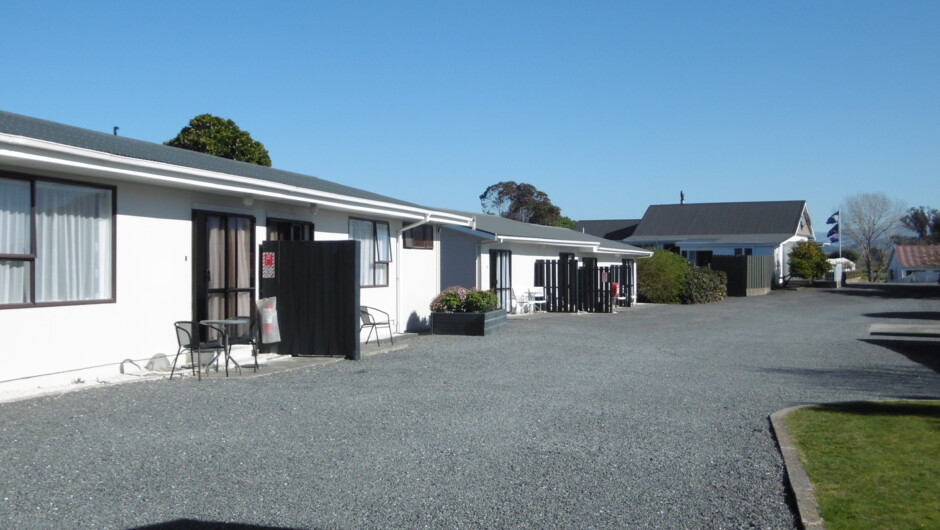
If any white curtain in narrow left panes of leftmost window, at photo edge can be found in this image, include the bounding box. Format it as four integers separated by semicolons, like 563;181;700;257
0;178;30;304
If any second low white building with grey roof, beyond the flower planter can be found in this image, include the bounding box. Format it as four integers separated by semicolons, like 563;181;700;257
440;210;652;310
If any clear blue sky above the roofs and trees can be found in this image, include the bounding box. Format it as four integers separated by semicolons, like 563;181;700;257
0;0;940;231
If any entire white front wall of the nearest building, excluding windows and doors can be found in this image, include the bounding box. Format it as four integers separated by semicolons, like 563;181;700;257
0;178;439;382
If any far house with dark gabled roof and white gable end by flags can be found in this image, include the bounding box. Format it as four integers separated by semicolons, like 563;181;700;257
624;201;816;284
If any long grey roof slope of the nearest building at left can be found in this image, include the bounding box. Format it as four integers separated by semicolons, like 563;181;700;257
0;111;426;208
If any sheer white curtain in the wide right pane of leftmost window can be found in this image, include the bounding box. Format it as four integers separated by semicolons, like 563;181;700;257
36;181;112;302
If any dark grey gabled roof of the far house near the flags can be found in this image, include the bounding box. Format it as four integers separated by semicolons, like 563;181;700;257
627;201;806;244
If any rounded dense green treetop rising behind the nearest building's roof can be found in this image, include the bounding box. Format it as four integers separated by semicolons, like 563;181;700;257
165;114;271;167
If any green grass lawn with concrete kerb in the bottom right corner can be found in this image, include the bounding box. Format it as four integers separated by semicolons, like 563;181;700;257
786;401;940;530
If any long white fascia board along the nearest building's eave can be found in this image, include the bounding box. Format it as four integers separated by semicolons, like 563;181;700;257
0;133;472;226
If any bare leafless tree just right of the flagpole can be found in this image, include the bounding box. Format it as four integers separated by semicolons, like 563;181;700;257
840;193;902;281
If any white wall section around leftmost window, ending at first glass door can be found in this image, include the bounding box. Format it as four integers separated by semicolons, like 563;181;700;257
0;176;192;380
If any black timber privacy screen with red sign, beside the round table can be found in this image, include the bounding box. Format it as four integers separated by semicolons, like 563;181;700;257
258;241;360;360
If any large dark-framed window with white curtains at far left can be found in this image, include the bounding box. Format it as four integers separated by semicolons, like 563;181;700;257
0;176;115;306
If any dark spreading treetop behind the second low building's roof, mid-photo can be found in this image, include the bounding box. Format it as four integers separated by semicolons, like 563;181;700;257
480;180;574;228
